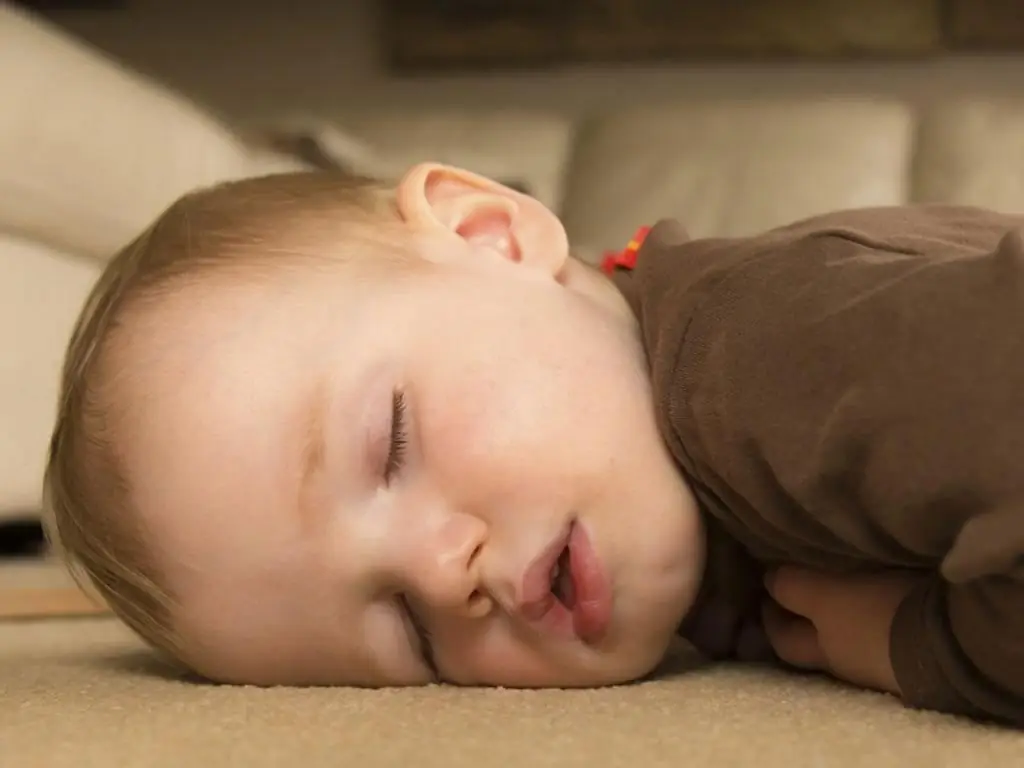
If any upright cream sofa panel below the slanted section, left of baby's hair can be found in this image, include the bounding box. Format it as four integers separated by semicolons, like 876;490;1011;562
0;233;101;517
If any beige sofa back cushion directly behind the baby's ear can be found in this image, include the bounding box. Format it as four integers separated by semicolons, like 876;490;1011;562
335;110;573;211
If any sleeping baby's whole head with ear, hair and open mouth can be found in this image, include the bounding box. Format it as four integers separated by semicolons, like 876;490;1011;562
46;165;702;686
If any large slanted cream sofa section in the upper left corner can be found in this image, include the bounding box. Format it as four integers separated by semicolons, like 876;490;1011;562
0;5;250;258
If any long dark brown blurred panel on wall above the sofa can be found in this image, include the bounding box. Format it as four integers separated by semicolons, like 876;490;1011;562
384;0;942;71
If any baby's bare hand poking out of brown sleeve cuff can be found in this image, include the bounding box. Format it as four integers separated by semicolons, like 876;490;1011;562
763;566;921;695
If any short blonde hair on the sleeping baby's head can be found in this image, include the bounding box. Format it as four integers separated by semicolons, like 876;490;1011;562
43;171;398;667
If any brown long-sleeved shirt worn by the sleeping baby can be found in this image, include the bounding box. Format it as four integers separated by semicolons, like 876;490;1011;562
614;206;1024;725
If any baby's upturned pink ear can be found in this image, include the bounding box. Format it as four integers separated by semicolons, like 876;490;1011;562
397;163;568;278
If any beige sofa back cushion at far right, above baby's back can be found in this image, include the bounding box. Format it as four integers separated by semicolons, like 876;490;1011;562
912;99;1024;212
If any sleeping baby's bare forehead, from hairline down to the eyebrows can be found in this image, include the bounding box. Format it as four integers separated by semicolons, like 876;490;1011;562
113;268;428;685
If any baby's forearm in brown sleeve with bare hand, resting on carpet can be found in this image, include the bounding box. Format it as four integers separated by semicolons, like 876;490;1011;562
764;559;1024;726
